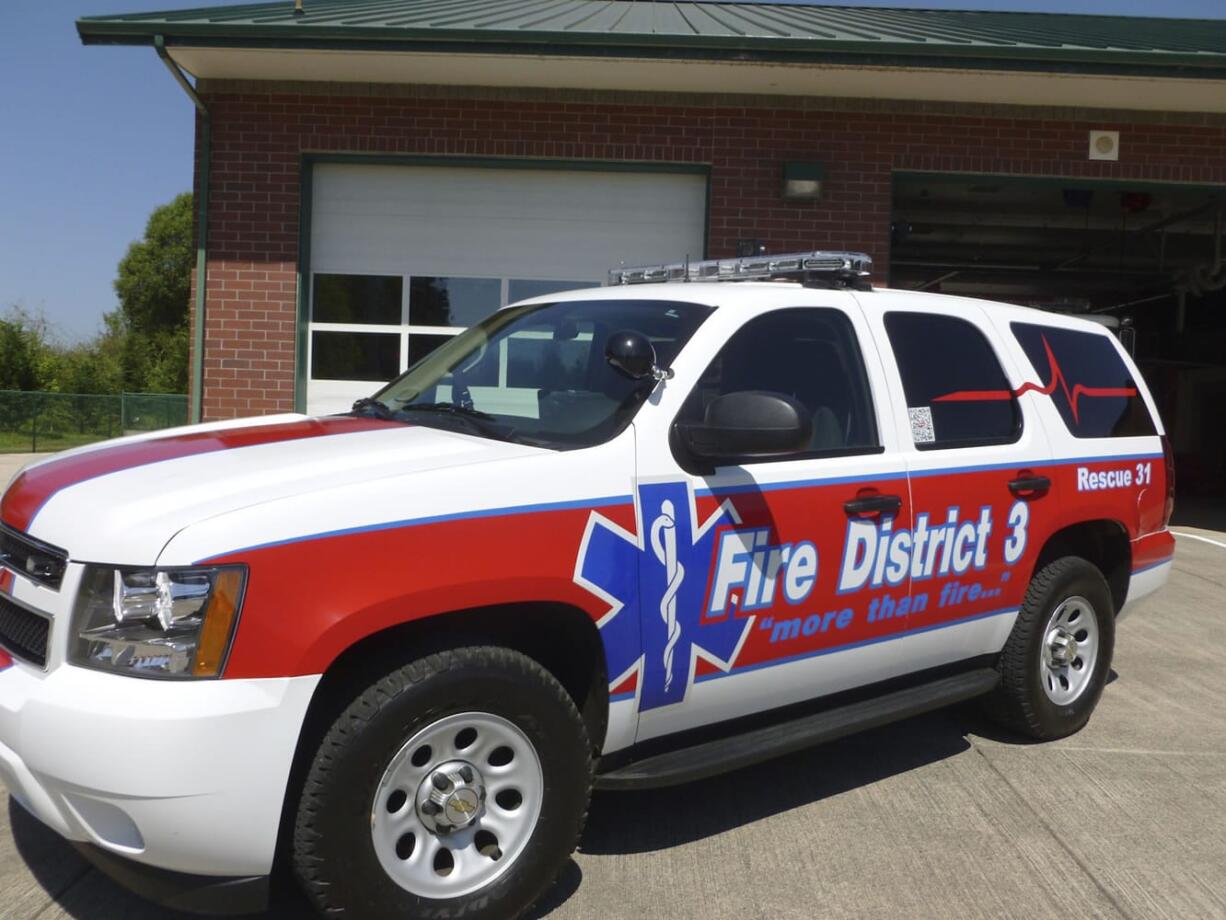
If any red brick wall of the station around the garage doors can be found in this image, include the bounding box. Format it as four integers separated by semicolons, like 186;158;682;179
191;83;1226;420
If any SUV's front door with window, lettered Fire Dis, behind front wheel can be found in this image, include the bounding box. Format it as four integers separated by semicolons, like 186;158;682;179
622;299;911;741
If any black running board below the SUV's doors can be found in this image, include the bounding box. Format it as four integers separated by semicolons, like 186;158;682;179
595;667;1000;790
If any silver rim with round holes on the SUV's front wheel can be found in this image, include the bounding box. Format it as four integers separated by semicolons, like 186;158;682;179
370;713;544;899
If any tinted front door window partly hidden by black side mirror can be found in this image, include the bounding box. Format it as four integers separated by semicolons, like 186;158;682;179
678;308;880;456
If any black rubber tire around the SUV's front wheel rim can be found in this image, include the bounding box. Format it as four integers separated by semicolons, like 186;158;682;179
293;646;592;920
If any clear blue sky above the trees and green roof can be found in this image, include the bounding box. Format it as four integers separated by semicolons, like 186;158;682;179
0;0;1226;341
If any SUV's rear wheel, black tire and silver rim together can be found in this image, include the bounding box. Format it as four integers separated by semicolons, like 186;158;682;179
987;556;1116;740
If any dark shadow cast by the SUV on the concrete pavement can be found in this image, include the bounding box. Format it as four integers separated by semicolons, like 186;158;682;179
9;704;1026;920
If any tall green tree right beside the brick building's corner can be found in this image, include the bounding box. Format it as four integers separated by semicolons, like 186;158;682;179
111;193;194;393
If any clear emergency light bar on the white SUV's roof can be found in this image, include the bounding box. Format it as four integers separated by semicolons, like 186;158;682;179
609;251;873;288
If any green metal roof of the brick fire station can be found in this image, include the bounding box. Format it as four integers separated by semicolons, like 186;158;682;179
77;0;1226;76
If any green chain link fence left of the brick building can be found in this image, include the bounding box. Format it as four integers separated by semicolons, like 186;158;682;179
0;390;188;454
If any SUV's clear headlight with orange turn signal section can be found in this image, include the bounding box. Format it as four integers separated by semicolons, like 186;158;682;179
69;565;246;677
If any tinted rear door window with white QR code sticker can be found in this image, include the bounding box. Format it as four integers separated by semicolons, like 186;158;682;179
885;313;1021;450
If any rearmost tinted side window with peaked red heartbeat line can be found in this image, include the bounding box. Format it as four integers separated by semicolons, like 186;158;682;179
1010;323;1157;438
